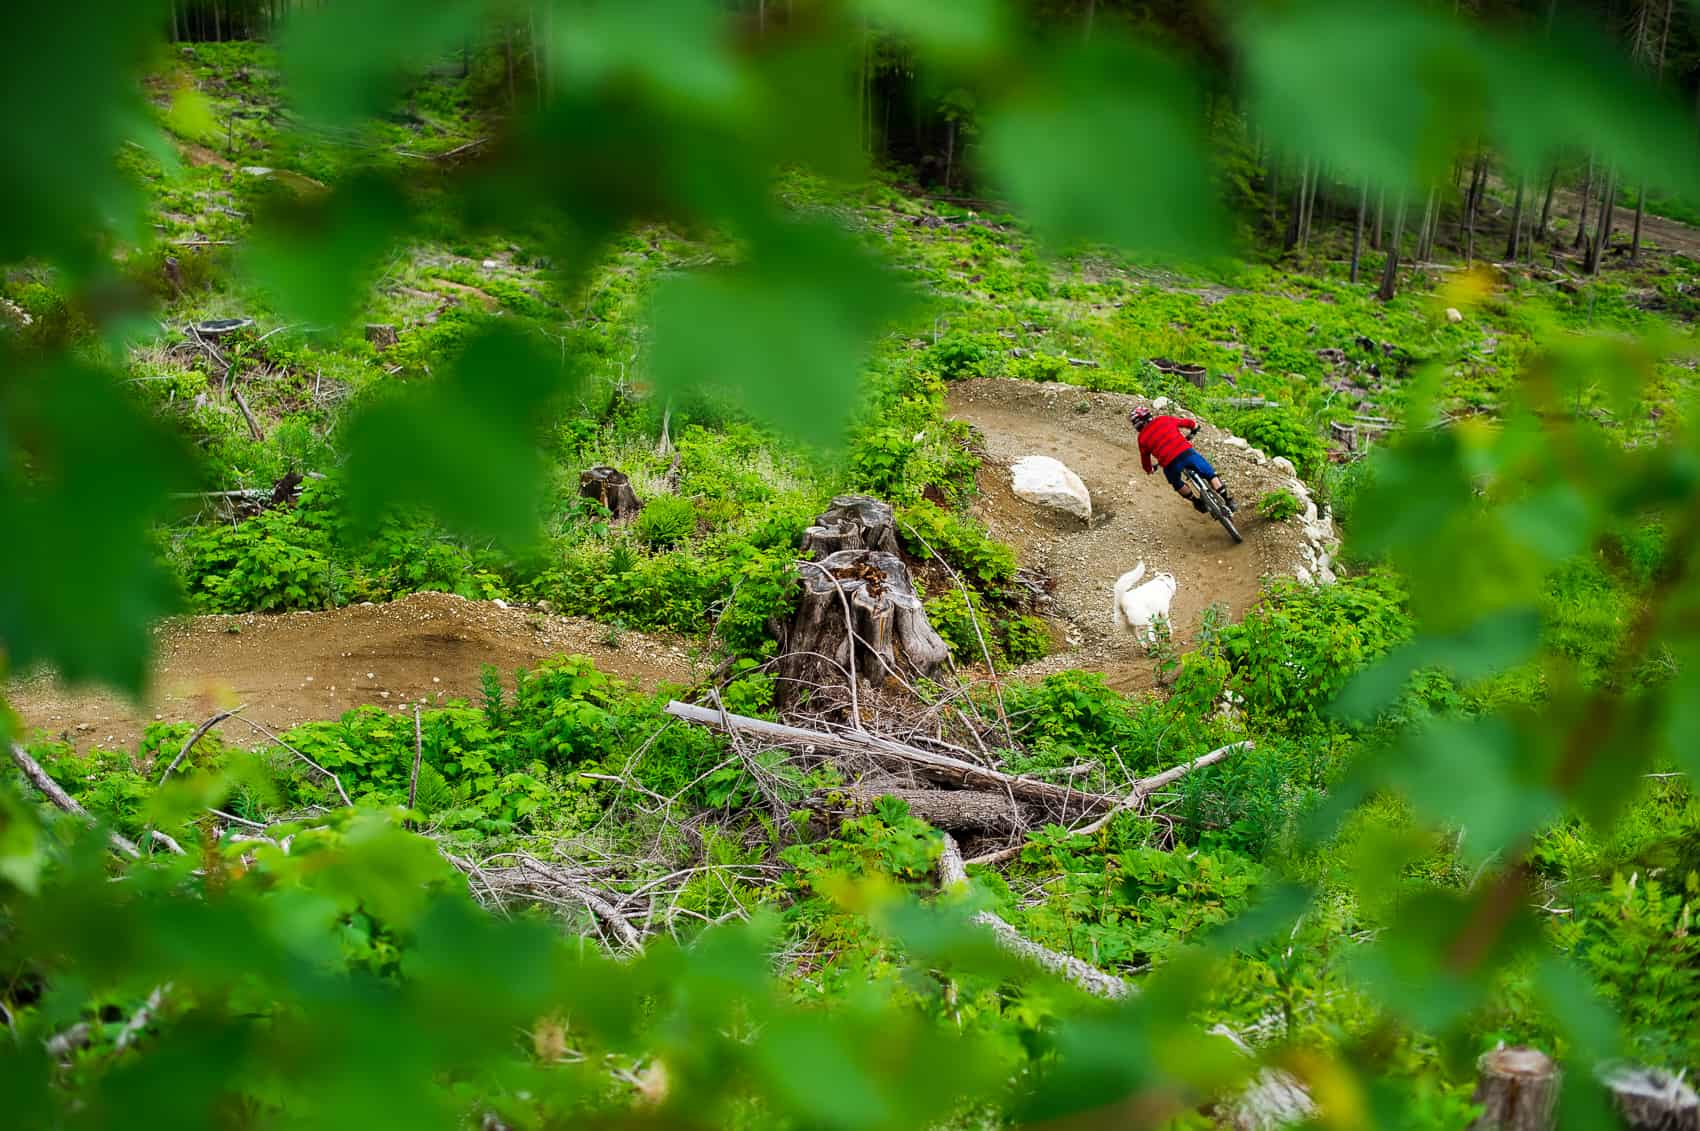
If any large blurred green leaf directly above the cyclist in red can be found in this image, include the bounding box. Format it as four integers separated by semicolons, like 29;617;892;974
983;36;1226;259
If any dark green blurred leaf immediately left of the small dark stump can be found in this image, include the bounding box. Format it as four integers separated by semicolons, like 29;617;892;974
347;328;570;546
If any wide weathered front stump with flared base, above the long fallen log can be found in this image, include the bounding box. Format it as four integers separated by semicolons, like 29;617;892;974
777;549;950;709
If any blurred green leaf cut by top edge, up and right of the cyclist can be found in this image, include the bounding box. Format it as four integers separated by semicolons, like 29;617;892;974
1239;0;1486;189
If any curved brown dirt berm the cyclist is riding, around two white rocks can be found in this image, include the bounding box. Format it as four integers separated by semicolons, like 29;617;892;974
950;379;1306;691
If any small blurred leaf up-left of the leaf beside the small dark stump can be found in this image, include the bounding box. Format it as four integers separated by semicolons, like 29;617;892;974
247;177;408;327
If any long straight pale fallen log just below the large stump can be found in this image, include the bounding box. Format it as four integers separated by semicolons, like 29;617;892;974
665;699;1117;816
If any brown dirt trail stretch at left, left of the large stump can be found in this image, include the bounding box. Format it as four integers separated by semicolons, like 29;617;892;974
3;594;692;750
